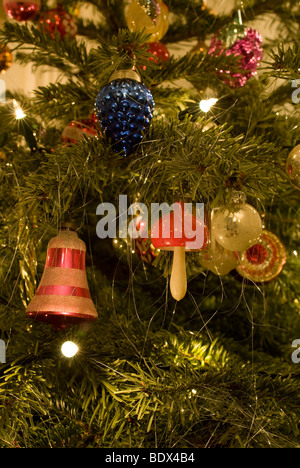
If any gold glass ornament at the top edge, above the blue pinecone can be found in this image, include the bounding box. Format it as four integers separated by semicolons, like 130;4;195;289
125;0;169;42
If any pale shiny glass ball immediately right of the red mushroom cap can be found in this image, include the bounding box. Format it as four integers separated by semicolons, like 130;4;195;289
211;203;262;252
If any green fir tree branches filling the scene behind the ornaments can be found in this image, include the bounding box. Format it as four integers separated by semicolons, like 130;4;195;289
0;0;300;448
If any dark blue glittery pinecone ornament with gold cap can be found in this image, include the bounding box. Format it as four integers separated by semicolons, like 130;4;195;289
95;70;155;157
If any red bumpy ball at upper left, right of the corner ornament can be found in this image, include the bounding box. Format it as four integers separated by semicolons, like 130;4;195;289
40;7;77;39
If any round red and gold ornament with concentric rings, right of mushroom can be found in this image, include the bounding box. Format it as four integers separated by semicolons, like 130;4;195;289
236;230;286;283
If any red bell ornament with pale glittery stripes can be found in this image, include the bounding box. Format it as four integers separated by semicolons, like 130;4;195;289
26;225;98;329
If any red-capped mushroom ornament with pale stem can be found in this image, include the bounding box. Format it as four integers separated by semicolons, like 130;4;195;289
151;202;207;301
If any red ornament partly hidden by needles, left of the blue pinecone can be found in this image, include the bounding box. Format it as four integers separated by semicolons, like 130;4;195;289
62;114;101;146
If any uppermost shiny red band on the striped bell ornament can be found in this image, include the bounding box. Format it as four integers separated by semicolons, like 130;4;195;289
45;248;85;271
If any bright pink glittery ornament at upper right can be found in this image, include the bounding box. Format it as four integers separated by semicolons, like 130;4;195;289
208;28;263;88
